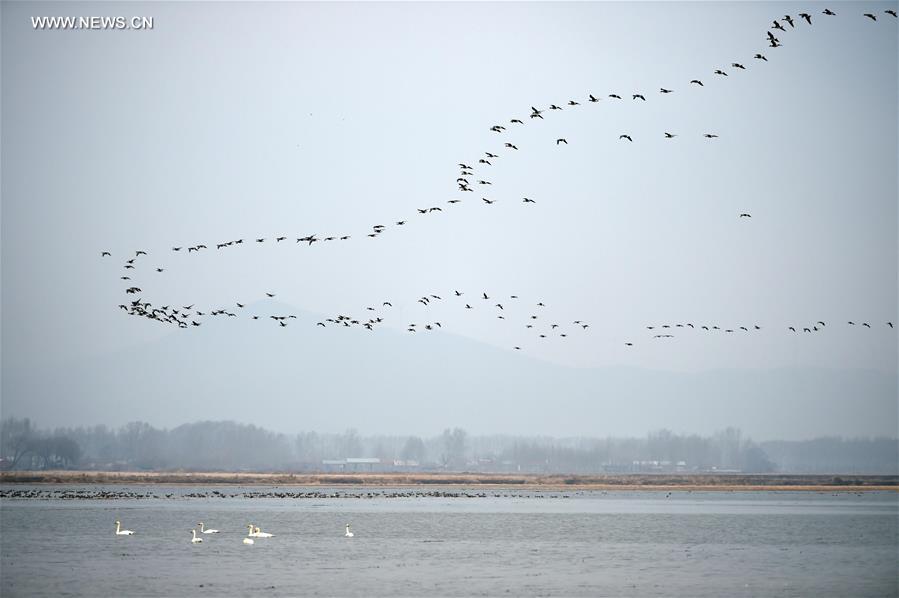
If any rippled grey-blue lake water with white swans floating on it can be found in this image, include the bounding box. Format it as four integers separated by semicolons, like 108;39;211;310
0;486;899;597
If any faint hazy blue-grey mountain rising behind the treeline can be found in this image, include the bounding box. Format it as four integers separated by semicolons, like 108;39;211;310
2;302;897;440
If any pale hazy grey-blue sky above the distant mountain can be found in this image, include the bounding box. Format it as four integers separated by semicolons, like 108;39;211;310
2;2;899;434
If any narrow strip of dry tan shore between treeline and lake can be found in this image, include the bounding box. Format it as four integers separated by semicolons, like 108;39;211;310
0;470;899;491
